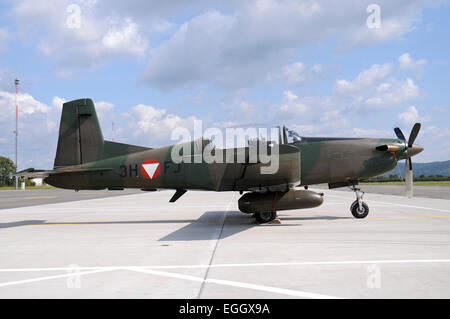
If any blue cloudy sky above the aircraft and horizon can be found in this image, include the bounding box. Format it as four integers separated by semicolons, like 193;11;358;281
0;0;450;170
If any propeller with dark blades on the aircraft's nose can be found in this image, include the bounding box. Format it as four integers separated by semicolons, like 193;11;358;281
394;123;423;198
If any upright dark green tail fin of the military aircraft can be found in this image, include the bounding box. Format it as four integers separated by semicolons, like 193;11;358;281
54;99;104;168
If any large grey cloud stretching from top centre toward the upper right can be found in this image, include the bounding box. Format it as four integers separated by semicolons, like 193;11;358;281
140;0;428;90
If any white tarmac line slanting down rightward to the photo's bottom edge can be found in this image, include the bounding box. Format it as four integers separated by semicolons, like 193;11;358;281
127;268;341;299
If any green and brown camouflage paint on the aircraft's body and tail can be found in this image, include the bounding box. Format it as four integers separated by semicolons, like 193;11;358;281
18;99;421;220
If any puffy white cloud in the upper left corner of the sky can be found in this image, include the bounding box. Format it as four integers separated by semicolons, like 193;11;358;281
12;0;148;77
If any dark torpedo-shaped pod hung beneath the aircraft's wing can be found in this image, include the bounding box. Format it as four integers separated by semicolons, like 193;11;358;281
238;190;323;214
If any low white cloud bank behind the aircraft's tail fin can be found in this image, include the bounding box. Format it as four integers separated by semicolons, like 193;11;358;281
0;91;200;169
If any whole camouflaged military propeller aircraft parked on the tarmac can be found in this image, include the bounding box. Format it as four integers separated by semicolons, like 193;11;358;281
17;99;423;223
